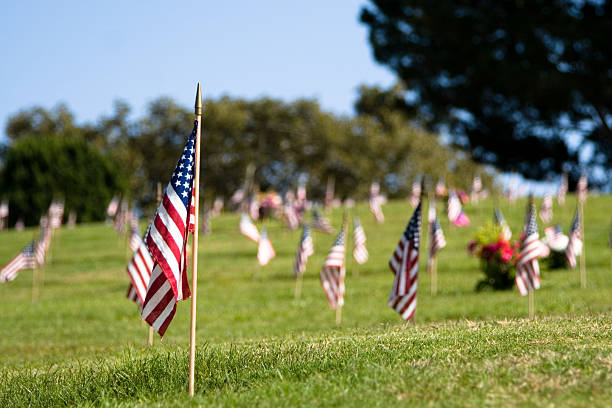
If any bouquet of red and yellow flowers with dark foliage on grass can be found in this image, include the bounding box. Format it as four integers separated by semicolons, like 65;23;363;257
467;223;519;290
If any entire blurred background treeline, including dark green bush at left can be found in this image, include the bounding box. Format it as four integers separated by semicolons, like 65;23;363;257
0;87;492;224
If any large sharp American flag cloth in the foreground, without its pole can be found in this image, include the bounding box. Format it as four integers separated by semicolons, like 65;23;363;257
142;121;198;336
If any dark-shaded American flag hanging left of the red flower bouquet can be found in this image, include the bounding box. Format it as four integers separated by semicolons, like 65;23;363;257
388;202;421;321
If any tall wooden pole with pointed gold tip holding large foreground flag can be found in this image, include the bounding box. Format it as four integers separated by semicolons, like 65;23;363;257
189;82;202;397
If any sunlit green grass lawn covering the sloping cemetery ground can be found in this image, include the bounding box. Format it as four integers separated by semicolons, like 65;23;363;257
0;197;612;406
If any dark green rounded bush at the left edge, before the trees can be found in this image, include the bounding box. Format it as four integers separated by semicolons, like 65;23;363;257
0;136;123;225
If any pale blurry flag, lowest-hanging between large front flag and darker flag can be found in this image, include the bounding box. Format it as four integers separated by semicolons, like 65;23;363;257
321;225;346;309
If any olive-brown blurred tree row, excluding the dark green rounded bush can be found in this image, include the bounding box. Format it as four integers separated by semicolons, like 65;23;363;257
6;97;493;212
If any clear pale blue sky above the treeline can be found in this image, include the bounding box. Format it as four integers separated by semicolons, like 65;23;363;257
0;0;394;139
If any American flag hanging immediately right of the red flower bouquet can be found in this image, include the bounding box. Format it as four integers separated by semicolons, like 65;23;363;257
515;198;542;296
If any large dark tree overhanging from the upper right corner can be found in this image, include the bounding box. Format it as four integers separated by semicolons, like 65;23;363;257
360;0;612;181
